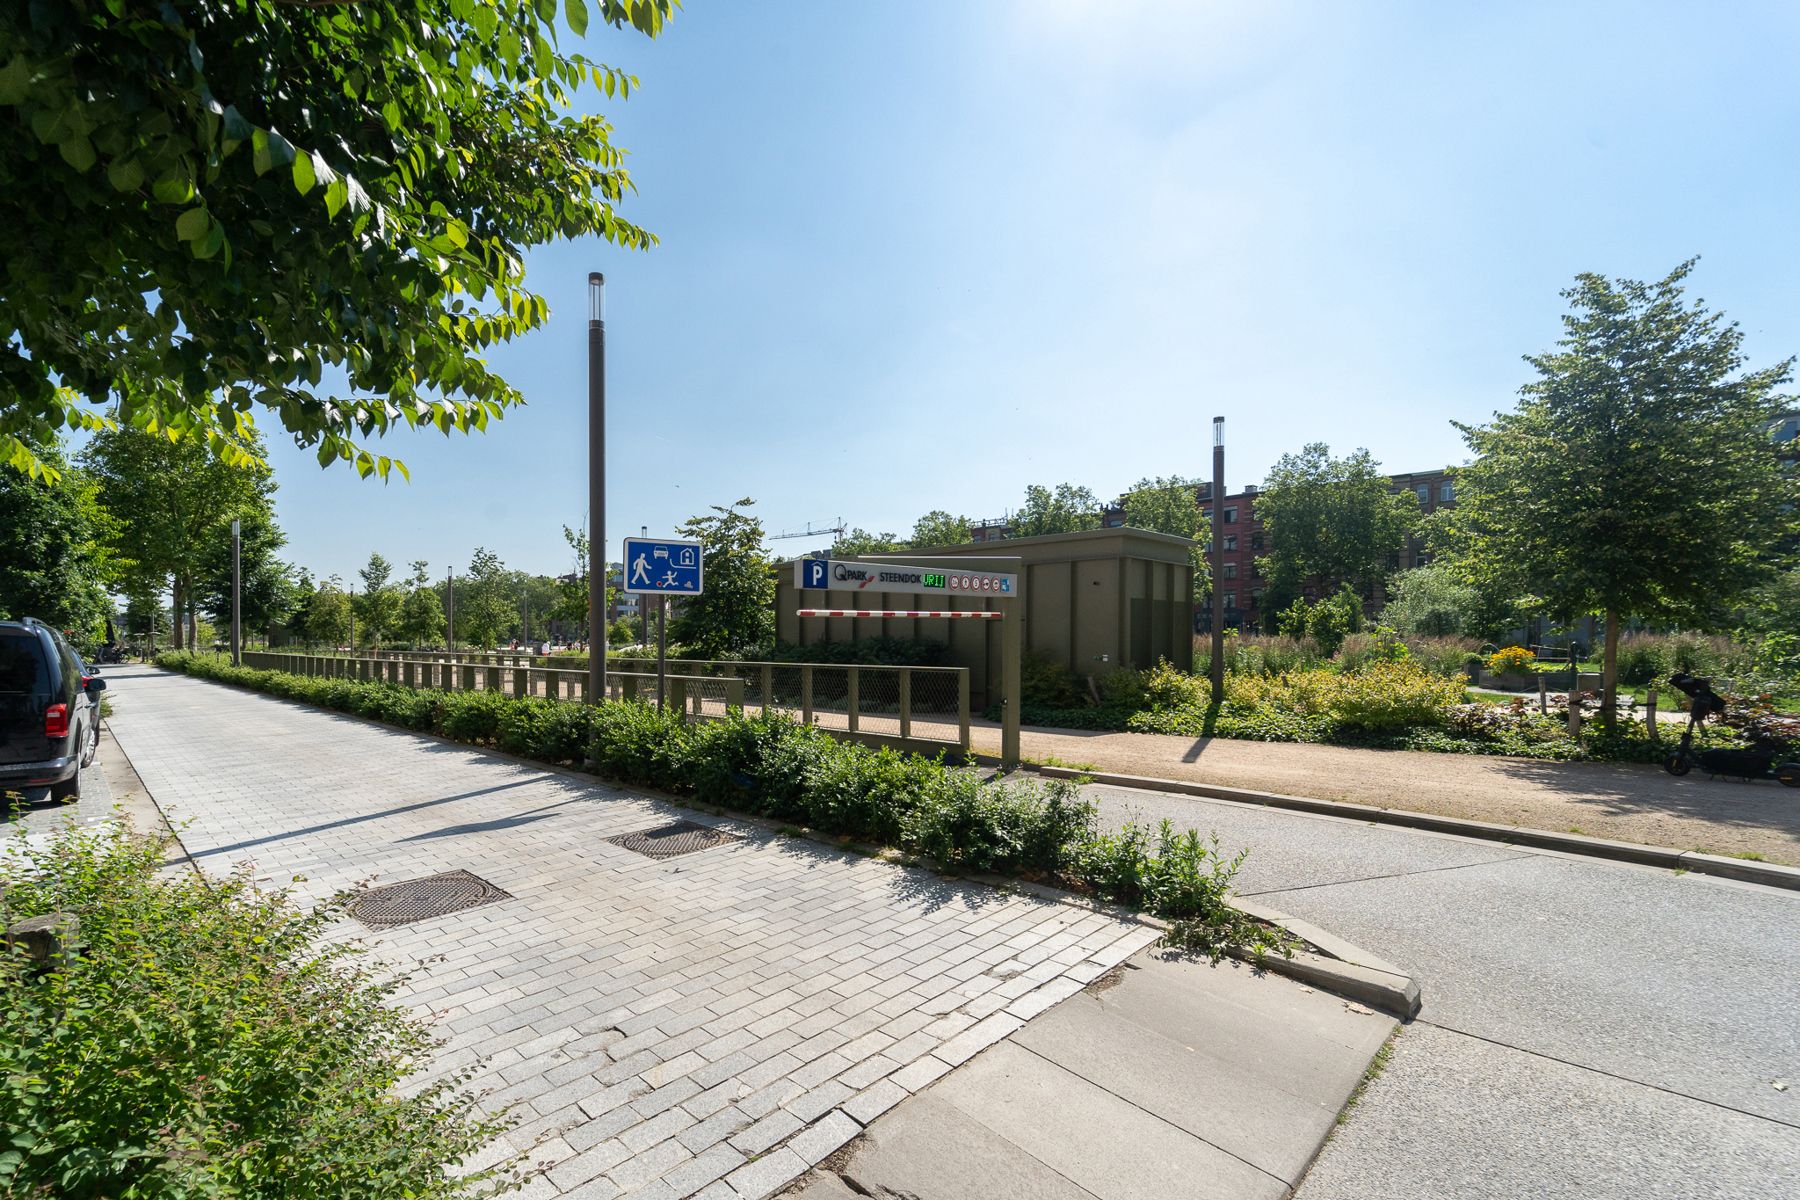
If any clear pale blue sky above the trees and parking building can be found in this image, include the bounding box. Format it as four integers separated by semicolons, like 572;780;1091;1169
272;0;1800;576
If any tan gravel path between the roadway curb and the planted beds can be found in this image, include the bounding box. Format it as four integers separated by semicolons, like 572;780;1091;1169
974;721;1800;865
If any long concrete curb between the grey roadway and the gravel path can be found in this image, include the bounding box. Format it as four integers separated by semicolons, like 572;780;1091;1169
976;754;1800;891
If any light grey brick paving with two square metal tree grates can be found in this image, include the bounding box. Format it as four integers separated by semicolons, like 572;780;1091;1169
108;667;1156;1200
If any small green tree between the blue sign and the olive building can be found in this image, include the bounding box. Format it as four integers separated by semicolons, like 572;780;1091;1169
670;497;776;658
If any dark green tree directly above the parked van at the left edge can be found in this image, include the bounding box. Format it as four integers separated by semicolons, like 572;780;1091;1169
0;443;112;640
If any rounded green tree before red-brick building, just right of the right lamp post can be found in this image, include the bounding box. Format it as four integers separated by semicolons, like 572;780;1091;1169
1256;443;1418;610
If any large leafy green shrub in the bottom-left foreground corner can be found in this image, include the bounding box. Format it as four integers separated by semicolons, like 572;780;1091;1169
0;822;504;1200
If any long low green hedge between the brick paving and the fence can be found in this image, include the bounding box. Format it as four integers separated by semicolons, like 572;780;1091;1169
157;655;1291;961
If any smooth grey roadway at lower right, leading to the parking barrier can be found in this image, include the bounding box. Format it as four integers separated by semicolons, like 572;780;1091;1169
1089;788;1800;1200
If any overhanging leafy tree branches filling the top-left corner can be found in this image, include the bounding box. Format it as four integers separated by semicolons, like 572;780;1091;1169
0;0;677;475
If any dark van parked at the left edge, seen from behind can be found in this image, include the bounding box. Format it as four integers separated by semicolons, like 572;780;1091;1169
0;617;106;801
